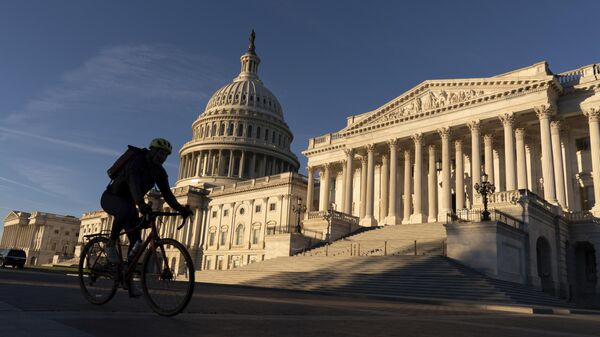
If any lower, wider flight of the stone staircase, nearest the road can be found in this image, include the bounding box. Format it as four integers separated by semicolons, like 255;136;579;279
196;255;567;307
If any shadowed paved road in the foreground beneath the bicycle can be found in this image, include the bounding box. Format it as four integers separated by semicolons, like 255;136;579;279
0;269;600;337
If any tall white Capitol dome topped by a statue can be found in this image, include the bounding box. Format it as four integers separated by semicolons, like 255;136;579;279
176;31;299;187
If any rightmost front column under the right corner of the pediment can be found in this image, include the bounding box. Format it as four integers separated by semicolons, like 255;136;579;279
535;105;558;205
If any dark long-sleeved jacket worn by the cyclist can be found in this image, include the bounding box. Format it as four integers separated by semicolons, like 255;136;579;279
108;149;182;210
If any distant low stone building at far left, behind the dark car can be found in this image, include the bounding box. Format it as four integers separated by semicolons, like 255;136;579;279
0;211;81;266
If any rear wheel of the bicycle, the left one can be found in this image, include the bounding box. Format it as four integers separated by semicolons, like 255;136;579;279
79;236;117;305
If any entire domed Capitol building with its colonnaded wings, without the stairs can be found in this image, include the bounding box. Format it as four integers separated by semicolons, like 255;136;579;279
0;33;600;304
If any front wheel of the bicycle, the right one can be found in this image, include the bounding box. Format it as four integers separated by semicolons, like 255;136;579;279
142;239;194;316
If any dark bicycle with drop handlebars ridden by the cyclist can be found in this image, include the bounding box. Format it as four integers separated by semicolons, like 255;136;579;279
78;212;194;316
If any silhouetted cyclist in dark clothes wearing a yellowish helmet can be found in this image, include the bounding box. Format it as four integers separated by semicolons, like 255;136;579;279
100;138;192;264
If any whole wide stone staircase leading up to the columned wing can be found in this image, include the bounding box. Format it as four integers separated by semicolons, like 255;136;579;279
196;223;568;307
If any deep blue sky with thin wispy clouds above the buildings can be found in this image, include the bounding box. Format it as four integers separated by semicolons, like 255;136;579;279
0;0;600;236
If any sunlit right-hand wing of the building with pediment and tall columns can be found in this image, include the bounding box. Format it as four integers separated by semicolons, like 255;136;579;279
303;62;600;297
